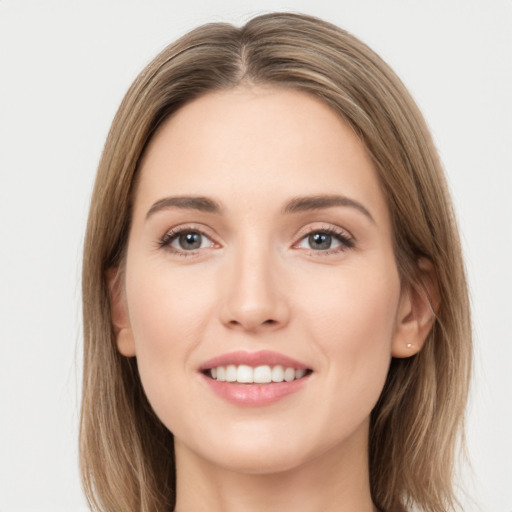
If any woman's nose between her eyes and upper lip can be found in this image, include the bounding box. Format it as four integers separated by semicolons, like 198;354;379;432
220;249;290;333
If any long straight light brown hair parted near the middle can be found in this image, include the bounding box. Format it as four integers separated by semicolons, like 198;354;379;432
80;13;471;512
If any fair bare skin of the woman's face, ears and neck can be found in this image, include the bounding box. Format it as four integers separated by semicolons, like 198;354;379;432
112;86;431;512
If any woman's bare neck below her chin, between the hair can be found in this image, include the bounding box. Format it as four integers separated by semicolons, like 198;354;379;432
175;422;377;512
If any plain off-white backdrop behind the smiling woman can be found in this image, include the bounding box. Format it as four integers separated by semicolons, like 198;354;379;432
0;0;512;512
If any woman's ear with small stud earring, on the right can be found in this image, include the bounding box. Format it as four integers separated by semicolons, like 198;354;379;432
392;258;440;357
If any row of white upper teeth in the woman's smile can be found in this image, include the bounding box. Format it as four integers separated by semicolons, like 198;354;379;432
210;364;306;384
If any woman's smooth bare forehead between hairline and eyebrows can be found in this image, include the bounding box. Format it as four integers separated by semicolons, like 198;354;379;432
136;86;387;222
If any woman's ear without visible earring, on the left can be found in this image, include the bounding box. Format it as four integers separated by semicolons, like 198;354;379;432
107;268;135;357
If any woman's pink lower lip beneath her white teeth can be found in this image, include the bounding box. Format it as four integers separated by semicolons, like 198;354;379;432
204;375;308;407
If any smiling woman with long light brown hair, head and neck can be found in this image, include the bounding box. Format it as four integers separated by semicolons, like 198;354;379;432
81;14;471;512
